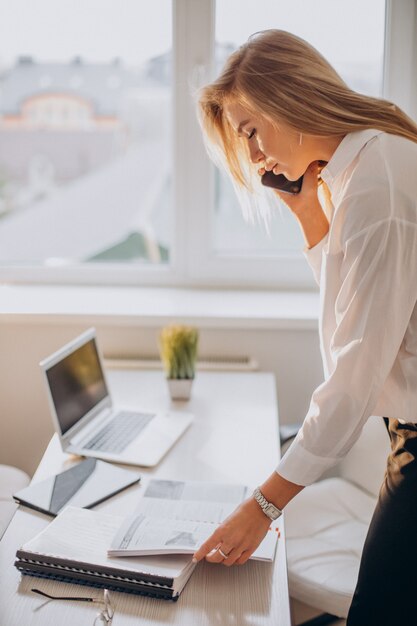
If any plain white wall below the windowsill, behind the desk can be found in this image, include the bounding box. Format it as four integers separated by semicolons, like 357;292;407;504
0;316;322;474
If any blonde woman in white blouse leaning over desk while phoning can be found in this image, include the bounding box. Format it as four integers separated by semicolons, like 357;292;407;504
195;30;417;626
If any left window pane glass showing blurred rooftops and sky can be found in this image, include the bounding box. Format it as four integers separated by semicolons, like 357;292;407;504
0;0;173;265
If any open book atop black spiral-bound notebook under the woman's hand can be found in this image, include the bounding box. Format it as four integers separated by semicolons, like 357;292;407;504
15;480;279;600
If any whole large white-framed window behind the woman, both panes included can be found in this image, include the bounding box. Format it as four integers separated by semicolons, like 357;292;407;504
0;0;417;287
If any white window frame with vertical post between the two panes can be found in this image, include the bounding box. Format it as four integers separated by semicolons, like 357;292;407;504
0;0;417;289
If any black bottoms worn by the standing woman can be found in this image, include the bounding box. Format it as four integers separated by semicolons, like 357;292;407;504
347;417;417;626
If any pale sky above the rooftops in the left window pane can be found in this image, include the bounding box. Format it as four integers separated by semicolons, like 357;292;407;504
0;0;173;66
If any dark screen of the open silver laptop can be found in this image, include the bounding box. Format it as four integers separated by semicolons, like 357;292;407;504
46;339;108;435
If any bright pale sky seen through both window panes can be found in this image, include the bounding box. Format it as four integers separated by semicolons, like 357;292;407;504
0;0;385;67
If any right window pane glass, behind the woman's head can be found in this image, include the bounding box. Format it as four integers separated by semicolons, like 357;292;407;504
212;0;385;256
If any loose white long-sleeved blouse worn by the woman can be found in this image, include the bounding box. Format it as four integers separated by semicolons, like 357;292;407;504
276;130;417;485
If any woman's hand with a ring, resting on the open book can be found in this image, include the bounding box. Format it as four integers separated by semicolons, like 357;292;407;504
194;498;271;565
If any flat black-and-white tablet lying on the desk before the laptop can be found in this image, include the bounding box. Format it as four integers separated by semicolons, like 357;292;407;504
13;459;140;516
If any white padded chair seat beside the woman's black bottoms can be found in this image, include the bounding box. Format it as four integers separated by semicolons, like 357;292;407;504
285;478;376;617
